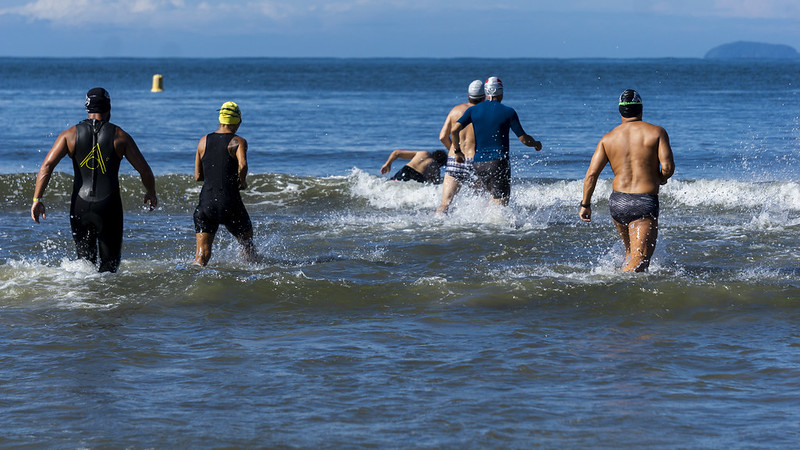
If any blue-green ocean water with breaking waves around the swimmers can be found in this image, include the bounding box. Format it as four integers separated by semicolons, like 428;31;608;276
0;58;800;448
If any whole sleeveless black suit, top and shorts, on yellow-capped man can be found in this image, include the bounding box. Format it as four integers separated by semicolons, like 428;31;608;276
194;133;253;237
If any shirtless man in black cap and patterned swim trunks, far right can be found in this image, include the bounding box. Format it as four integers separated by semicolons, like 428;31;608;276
579;89;675;272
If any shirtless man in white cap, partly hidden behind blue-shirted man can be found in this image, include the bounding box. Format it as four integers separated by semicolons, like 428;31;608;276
436;80;486;213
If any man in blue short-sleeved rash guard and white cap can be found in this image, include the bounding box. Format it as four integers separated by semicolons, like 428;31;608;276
451;77;542;206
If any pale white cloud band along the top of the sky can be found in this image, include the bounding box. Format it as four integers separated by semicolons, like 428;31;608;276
0;0;800;29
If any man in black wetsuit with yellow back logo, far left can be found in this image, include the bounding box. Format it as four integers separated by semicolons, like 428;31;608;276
31;88;158;272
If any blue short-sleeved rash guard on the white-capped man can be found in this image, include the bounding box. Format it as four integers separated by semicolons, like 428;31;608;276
458;100;525;162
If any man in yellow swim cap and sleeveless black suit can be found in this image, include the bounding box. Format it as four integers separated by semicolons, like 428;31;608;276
194;102;256;266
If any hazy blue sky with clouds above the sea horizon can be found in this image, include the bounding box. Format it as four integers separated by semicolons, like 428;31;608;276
0;0;800;58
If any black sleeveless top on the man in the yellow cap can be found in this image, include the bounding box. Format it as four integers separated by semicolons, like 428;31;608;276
200;133;241;203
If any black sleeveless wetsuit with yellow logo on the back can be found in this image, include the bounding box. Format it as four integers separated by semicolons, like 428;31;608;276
69;119;122;272
